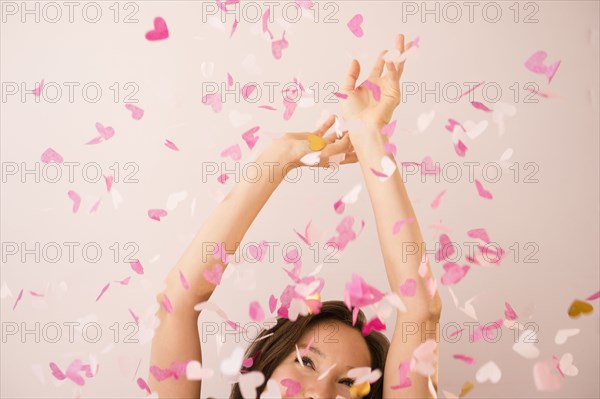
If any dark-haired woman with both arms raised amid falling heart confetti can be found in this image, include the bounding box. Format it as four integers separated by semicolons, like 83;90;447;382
149;34;441;399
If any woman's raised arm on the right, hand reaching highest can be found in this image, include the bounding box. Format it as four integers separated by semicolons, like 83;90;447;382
343;35;441;398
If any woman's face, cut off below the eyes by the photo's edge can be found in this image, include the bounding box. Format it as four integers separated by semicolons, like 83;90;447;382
271;320;371;399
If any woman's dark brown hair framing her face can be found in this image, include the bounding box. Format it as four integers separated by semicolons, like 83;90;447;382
229;301;390;399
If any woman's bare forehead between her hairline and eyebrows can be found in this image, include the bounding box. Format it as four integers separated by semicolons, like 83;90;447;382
298;320;371;367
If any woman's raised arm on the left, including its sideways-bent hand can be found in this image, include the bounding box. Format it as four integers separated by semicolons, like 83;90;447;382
148;117;356;399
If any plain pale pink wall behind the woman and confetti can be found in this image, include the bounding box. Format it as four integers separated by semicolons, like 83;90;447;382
0;1;600;398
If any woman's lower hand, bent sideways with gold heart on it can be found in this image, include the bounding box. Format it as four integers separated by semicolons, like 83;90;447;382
272;115;358;168
